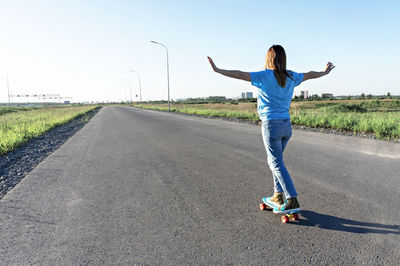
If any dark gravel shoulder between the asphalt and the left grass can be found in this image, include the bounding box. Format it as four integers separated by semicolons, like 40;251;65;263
0;107;101;199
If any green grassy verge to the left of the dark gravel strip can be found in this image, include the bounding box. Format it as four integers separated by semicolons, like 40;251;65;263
0;106;97;155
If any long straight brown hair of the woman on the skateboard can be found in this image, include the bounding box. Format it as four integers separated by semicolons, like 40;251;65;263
265;45;292;87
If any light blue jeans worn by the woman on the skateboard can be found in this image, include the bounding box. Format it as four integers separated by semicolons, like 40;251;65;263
261;119;297;198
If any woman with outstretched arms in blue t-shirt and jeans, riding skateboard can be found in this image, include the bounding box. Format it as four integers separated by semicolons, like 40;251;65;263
208;45;335;213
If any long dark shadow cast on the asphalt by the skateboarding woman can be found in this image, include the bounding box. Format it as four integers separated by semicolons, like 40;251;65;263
298;210;400;235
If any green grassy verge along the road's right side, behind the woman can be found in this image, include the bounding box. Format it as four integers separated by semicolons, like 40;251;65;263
137;99;400;140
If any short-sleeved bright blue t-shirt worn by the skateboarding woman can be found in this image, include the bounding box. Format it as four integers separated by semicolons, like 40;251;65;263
250;69;304;122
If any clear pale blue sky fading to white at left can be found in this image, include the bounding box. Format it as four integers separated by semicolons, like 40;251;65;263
0;0;400;102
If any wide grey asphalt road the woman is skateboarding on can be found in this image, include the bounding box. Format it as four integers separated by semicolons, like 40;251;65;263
0;107;400;265
